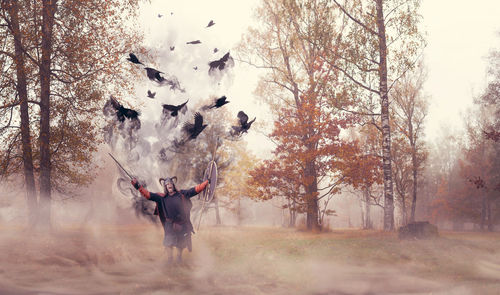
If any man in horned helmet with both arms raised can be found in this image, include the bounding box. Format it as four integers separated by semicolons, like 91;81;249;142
131;176;208;264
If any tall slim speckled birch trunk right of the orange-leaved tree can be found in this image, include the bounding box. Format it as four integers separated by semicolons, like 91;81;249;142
376;0;394;231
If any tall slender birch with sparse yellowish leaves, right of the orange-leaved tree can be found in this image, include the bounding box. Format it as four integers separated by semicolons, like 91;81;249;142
323;0;423;230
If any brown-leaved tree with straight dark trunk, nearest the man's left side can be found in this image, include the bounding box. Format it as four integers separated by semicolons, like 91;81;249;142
0;0;146;226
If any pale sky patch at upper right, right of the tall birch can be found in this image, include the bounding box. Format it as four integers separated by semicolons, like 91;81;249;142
421;0;500;139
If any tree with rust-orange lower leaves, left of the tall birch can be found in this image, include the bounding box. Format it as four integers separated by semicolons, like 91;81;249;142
239;0;358;230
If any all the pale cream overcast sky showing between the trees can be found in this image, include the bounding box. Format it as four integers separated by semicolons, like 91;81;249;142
137;0;500;154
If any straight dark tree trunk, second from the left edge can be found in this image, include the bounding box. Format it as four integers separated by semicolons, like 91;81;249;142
40;0;57;228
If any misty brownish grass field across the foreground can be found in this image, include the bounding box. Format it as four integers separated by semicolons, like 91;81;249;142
0;224;500;294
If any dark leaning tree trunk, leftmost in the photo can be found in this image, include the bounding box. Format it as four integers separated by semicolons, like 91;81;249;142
2;1;38;227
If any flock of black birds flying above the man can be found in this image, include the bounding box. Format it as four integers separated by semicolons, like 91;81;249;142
105;15;256;155
